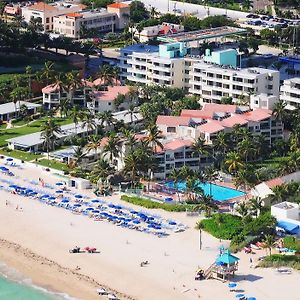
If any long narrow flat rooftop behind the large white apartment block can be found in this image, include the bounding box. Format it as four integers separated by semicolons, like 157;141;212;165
157;26;247;43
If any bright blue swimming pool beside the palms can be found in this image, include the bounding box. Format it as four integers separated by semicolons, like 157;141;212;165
165;181;245;202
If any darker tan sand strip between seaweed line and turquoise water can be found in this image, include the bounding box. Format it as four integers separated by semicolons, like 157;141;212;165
0;238;134;300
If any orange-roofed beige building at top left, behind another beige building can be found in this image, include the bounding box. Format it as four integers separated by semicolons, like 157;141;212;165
22;2;85;31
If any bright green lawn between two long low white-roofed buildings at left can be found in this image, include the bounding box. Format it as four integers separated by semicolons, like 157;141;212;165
0;117;72;147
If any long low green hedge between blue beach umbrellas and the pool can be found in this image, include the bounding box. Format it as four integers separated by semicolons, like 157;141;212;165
121;195;194;212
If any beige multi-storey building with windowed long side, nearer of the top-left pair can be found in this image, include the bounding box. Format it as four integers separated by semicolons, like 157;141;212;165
53;9;117;38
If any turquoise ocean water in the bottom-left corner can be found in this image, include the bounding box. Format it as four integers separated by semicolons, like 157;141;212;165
0;263;74;300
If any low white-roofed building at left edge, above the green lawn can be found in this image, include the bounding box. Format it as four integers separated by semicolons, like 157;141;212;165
0;101;41;121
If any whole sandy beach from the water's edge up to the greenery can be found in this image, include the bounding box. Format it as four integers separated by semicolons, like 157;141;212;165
0;161;300;300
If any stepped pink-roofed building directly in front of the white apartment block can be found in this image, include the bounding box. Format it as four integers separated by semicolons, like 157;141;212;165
156;103;283;144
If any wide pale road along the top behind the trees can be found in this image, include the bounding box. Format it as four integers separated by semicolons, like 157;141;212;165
126;0;249;19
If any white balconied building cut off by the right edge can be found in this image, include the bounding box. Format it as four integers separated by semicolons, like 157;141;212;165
280;77;300;109
